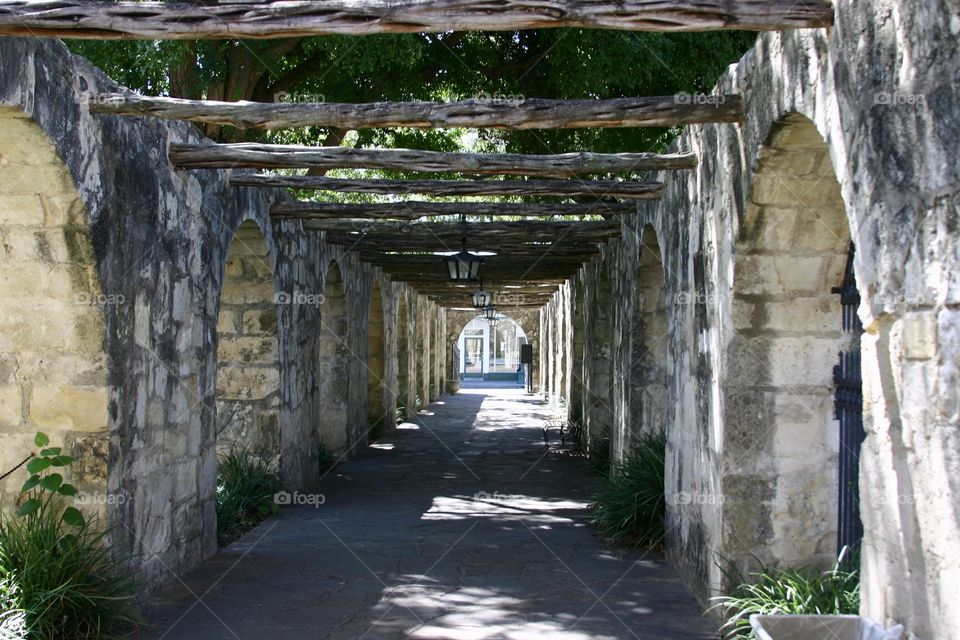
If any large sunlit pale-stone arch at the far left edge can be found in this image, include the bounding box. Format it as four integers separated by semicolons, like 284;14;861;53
0;107;109;511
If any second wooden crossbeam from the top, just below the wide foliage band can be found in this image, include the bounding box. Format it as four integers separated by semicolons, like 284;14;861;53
89;93;743;130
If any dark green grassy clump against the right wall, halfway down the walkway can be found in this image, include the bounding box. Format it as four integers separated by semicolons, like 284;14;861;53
590;432;667;546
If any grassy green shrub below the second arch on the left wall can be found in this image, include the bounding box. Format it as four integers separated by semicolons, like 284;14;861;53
216;449;280;545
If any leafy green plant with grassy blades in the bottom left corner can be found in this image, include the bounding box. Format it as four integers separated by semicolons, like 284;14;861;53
0;433;140;640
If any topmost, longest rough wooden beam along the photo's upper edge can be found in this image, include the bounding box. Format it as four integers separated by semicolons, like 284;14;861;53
0;0;833;40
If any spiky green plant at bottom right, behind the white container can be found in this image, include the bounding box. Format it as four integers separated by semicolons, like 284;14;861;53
710;552;860;640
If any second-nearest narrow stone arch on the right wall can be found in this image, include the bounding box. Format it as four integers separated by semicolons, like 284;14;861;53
624;225;669;451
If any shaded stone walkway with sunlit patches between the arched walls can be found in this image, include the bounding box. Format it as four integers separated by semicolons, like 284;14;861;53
140;388;717;640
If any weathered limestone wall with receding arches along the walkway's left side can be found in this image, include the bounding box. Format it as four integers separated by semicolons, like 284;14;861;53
0;38;413;587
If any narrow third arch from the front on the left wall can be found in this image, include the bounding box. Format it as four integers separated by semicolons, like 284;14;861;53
317;262;350;455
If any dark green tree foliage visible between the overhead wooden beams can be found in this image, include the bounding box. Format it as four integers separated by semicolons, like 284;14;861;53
68;29;756;153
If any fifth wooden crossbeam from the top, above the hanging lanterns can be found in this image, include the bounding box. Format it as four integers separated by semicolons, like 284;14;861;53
270;201;637;220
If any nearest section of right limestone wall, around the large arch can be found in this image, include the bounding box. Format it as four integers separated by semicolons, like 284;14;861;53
641;0;960;638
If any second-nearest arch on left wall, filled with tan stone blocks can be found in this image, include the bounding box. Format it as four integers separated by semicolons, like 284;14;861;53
216;220;283;460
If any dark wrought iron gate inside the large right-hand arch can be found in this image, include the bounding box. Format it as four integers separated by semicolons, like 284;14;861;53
833;244;866;553
